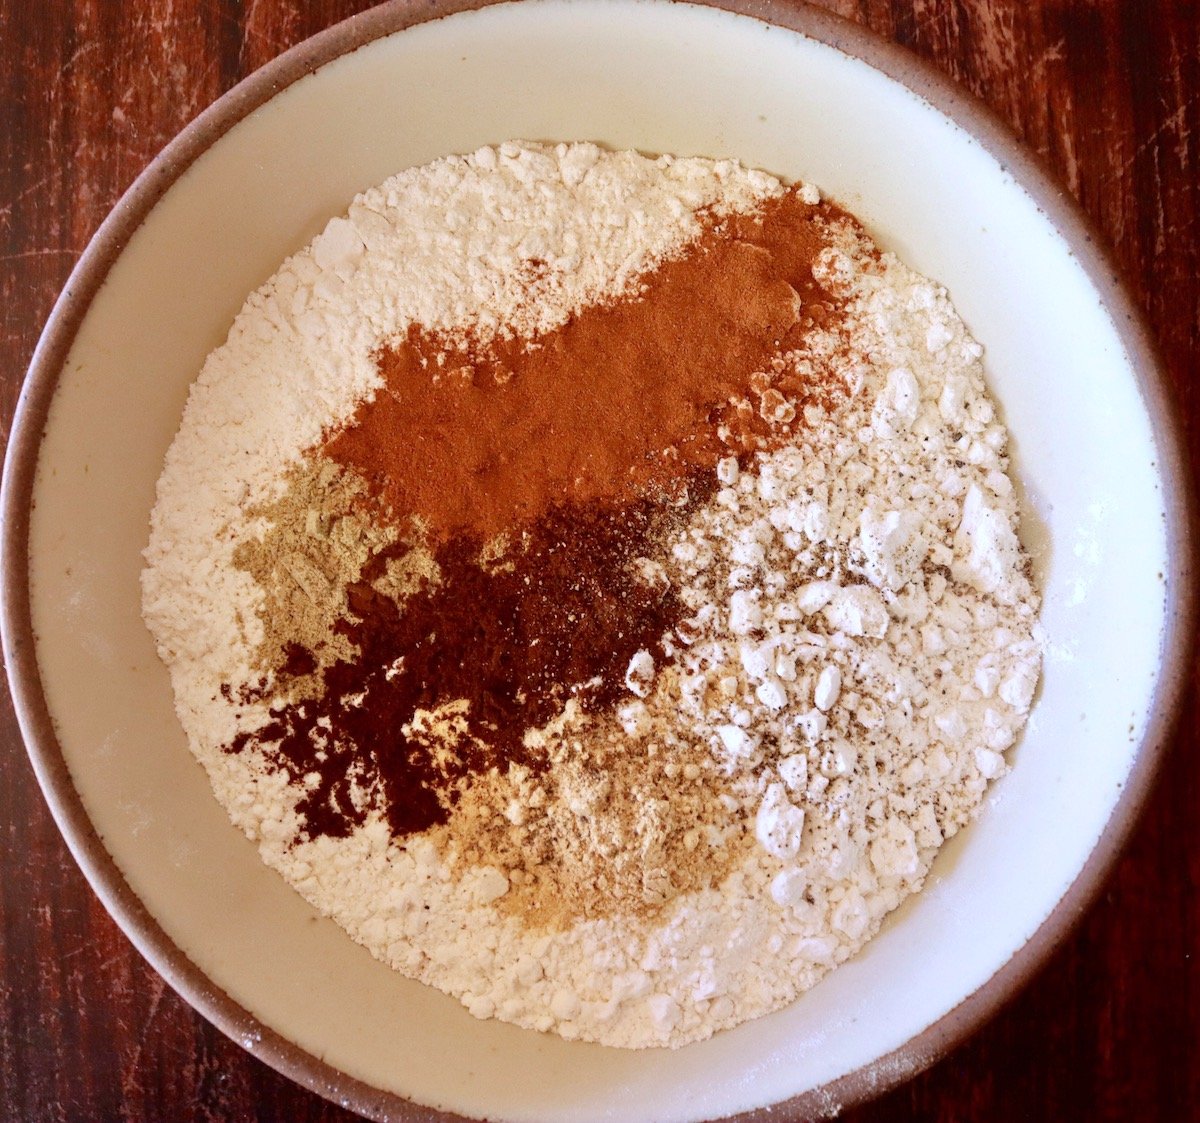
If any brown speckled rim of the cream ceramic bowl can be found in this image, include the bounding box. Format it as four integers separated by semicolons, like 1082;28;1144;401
0;0;1196;1121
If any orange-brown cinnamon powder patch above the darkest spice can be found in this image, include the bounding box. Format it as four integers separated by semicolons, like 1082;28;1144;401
324;191;846;539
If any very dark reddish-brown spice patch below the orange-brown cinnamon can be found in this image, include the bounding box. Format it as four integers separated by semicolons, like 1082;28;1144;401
232;482;714;837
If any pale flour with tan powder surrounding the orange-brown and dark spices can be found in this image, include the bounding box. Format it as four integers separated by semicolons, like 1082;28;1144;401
143;145;1039;1047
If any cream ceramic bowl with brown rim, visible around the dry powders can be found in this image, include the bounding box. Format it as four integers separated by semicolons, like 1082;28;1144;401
4;0;1190;1121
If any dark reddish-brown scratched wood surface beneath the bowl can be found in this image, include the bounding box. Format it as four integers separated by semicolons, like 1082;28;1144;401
0;0;1200;1123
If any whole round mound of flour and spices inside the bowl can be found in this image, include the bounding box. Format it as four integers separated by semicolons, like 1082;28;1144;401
143;144;1039;1047
